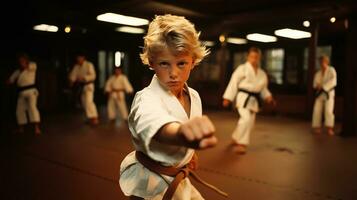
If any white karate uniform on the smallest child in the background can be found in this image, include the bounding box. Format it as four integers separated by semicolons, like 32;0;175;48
105;74;133;120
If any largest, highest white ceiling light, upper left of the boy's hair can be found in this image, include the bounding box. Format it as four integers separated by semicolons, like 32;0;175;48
97;13;149;26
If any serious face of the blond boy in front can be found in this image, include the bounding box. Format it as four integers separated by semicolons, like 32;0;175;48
150;49;193;94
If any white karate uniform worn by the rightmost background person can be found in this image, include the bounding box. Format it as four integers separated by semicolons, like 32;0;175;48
312;67;337;128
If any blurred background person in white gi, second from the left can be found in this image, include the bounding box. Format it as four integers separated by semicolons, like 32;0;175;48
69;54;98;125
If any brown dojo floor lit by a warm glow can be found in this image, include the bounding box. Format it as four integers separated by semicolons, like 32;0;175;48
0;111;357;200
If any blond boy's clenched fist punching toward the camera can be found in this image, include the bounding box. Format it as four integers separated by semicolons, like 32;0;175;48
178;116;217;149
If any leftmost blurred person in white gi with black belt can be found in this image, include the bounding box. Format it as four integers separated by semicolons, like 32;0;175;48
8;54;41;135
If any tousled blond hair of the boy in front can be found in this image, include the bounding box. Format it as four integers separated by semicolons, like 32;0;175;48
140;14;209;65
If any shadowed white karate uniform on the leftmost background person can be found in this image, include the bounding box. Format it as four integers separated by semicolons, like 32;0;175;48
10;62;40;125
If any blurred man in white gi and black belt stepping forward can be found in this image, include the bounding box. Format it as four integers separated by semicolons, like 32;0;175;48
222;47;275;154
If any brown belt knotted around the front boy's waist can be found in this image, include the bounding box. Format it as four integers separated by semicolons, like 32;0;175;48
135;151;228;200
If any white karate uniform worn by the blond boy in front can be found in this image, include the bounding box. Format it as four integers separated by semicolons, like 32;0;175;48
119;75;203;200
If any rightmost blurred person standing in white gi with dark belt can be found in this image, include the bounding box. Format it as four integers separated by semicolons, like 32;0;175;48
312;56;337;135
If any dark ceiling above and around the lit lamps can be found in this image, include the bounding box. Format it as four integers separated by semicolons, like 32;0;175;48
5;0;357;39
